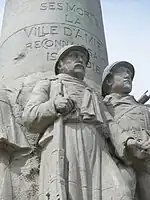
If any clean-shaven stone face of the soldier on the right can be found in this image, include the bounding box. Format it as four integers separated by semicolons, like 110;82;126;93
111;66;132;94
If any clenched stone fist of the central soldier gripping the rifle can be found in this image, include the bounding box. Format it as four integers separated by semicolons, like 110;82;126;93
54;95;75;115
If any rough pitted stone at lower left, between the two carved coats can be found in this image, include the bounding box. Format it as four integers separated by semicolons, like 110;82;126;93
9;154;39;200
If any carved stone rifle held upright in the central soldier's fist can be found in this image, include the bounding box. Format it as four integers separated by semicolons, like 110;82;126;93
50;80;67;200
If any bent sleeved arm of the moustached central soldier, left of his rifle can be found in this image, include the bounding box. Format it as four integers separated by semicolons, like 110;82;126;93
23;80;57;133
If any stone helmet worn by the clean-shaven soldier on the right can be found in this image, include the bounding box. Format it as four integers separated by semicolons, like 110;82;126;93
101;61;135;97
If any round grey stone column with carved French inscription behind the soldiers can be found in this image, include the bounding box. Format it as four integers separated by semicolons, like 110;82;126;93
0;0;108;87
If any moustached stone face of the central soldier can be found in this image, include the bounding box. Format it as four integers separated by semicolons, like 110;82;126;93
62;51;87;80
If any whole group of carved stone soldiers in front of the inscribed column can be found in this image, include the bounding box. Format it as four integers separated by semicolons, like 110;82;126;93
0;45;150;200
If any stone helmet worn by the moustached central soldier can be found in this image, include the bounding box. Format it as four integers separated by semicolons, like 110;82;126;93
55;45;90;75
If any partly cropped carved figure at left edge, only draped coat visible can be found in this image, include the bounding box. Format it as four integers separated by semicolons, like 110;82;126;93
0;86;31;200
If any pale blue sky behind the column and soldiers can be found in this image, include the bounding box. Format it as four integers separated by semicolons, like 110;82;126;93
0;0;150;98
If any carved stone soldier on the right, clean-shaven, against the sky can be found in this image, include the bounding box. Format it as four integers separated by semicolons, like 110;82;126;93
102;61;150;200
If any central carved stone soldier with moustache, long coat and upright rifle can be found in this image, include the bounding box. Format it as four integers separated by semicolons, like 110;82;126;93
23;45;135;200
